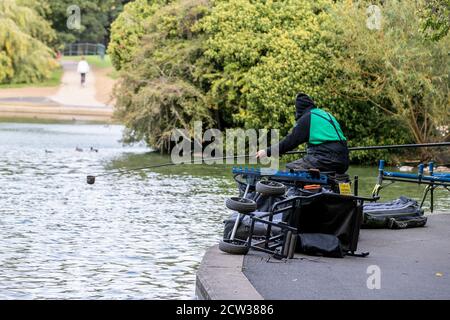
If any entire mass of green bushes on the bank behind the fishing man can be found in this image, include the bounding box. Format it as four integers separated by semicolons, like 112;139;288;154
109;0;450;162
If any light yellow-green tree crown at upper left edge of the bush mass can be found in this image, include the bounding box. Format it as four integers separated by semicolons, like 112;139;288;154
108;0;169;70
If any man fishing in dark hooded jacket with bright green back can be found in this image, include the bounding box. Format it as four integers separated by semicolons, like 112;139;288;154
256;93;349;174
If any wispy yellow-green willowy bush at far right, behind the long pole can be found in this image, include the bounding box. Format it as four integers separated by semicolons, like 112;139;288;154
327;1;450;157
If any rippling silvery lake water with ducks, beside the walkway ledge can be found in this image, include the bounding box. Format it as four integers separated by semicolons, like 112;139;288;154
0;122;450;299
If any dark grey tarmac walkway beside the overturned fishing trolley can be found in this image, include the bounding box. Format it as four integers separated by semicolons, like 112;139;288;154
243;214;450;300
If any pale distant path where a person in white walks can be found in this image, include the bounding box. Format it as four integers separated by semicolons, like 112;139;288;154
49;61;110;108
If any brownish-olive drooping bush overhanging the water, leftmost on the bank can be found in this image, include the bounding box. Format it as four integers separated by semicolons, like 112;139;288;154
114;0;212;151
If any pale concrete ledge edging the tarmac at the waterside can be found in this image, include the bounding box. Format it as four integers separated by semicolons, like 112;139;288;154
195;246;263;300
